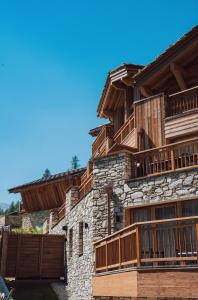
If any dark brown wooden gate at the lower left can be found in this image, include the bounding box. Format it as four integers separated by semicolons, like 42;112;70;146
1;232;65;279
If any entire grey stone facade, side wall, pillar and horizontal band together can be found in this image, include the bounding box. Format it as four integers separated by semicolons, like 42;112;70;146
50;152;198;300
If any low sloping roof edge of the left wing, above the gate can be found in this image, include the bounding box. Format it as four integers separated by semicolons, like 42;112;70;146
8;168;86;193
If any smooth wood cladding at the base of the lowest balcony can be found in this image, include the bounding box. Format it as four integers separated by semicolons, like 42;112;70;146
93;269;198;299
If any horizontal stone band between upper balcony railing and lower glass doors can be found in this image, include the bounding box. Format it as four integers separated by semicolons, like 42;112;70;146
123;169;198;207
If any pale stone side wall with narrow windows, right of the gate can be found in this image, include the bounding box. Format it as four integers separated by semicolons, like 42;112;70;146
49;191;93;300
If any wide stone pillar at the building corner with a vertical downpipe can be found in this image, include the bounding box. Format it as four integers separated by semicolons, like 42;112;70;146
93;152;131;239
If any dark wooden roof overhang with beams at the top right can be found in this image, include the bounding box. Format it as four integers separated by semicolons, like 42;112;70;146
134;26;198;96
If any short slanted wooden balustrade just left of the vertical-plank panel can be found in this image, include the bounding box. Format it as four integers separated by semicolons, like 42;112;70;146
113;114;135;144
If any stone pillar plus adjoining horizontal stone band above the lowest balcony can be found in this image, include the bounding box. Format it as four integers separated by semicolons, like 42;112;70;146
93;153;198;239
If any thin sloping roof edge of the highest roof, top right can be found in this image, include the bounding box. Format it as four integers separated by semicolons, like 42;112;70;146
134;25;198;81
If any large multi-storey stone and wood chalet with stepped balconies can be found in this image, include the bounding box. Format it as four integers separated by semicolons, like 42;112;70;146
8;26;198;300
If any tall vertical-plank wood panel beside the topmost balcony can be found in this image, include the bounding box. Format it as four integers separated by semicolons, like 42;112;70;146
134;94;165;150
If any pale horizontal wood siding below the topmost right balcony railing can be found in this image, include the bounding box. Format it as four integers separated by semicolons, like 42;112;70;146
165;109;198;139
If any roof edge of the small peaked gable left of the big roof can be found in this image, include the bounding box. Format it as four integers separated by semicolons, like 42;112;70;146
97;63;144;115
